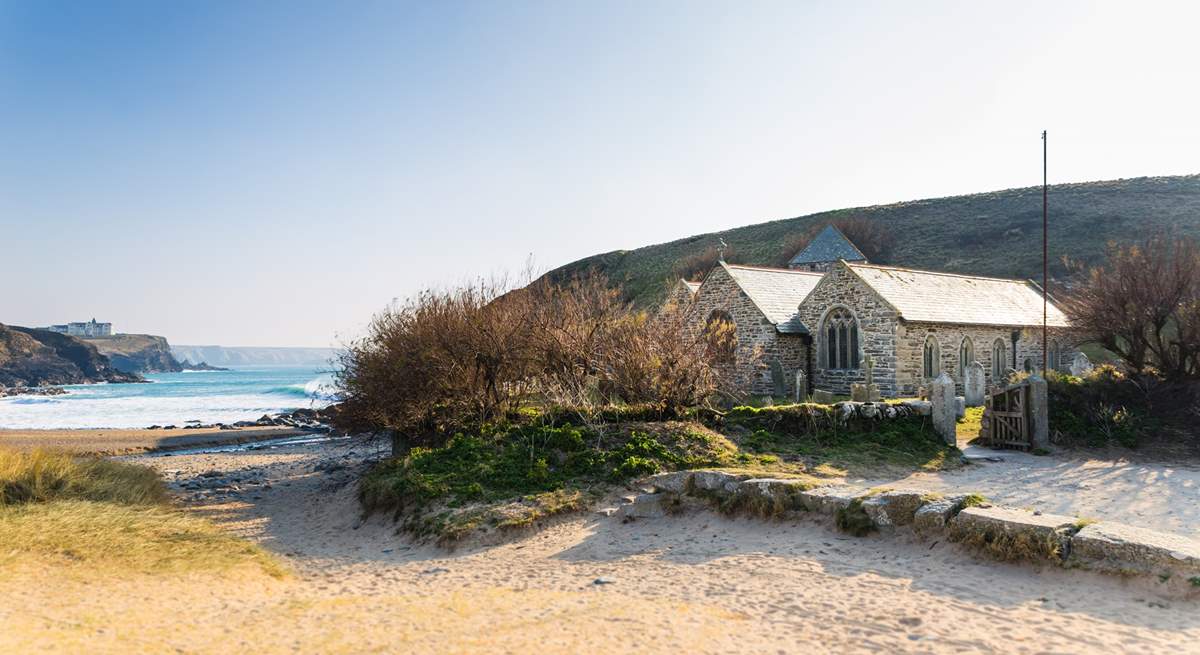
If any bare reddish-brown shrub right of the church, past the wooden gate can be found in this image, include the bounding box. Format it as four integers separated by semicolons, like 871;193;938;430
1064;234;1200;379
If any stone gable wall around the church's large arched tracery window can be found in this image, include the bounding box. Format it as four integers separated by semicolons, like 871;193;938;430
800;264;896;396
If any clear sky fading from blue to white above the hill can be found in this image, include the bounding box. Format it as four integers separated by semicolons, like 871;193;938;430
0;0;1200;347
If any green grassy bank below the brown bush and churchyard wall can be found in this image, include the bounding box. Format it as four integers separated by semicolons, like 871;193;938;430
359;405;960;546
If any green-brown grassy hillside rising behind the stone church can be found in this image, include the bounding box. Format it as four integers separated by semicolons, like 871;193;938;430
547;175;1200;305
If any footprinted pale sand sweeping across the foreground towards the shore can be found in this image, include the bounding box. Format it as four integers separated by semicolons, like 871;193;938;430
0;440;1200;653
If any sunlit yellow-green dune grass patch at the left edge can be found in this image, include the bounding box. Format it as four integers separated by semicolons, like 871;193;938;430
0;450;284;577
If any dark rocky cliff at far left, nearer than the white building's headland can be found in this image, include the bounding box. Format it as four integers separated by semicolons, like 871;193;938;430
0;324;142;386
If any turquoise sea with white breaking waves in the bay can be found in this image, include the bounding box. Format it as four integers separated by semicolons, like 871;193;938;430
0;366;335;429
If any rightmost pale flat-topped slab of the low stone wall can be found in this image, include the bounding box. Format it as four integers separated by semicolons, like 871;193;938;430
1070;522;1200;577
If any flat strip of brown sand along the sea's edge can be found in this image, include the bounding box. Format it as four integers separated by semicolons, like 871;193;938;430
0;426;317;457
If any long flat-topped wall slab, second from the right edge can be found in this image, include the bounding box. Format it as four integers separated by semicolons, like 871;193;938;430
950;505;1076;559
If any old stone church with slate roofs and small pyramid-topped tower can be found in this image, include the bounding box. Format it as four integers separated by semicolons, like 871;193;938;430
668;226;1078;397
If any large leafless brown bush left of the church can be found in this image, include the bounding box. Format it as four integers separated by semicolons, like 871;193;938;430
337;269;721;445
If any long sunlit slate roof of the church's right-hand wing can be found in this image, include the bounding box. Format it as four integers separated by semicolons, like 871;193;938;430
846;262;1070;328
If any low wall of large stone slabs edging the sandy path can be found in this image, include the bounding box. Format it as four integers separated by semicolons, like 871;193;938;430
624;470;1200;597
